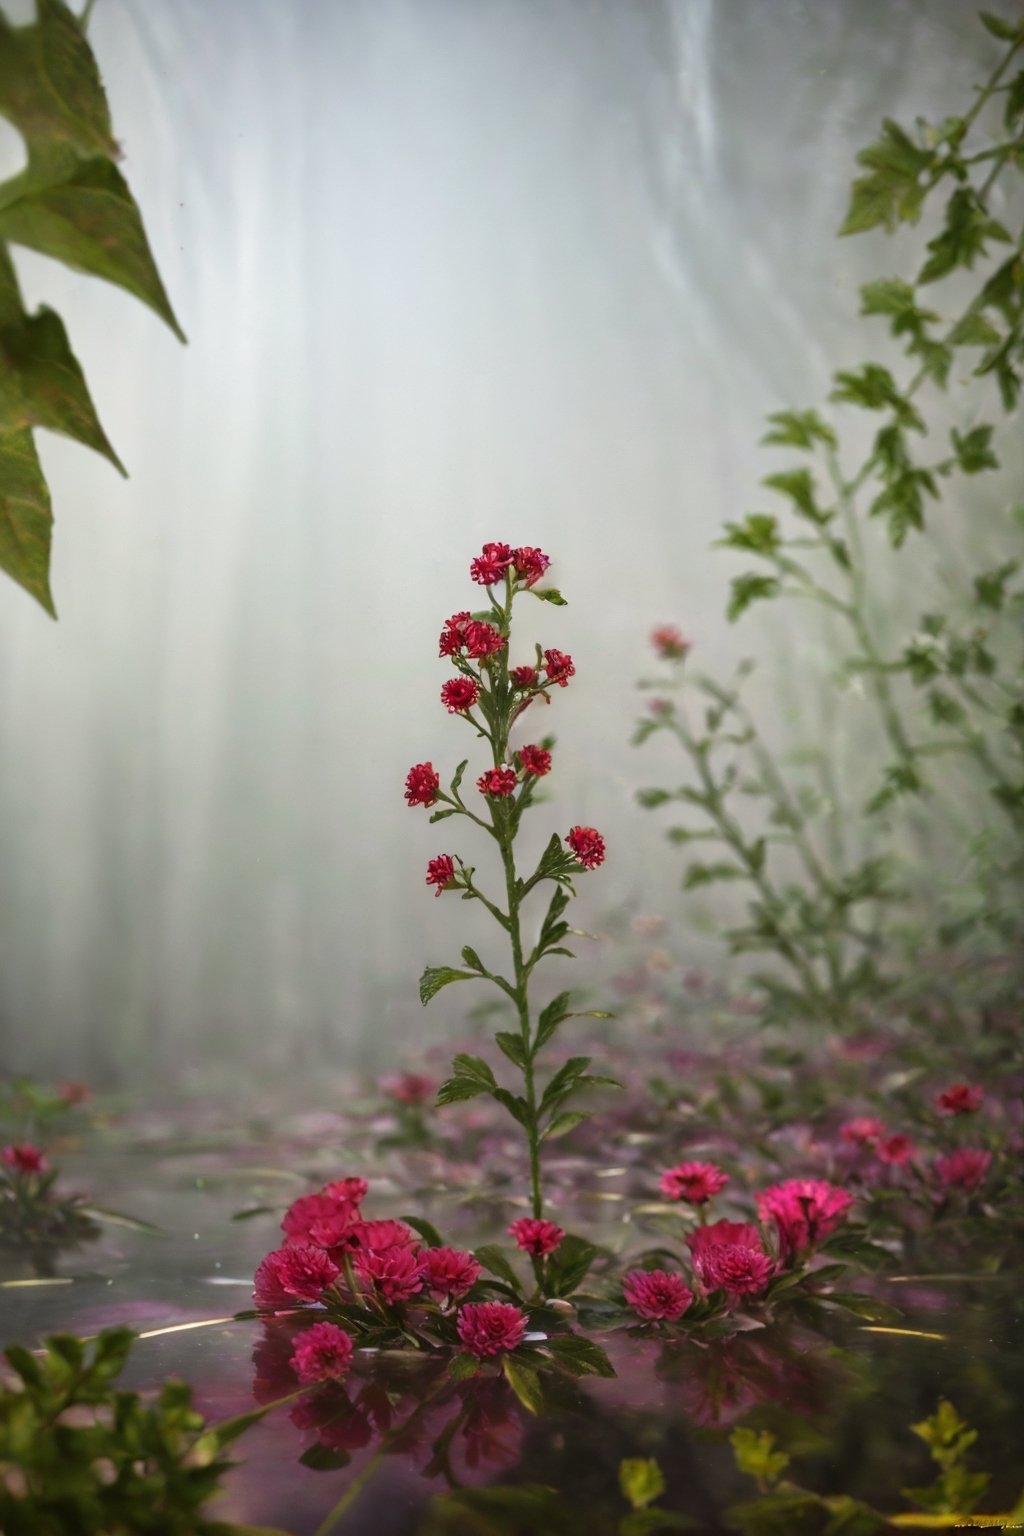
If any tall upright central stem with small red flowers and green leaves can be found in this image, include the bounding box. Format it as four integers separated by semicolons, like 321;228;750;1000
405;544;617;1228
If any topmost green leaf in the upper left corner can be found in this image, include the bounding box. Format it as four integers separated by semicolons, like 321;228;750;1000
0;0;118;157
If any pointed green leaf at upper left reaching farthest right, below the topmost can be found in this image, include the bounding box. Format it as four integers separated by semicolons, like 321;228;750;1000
0;146;186;341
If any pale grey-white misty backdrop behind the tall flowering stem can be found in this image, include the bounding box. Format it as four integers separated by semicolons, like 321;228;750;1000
0;0;1012;1084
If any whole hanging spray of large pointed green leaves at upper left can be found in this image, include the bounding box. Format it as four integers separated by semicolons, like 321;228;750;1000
0;0;184;617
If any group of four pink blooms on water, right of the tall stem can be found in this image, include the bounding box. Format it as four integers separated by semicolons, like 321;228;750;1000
623;1161;854;1322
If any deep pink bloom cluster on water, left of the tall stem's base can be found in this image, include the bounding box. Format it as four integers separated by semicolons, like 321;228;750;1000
253;1178;534;1363
